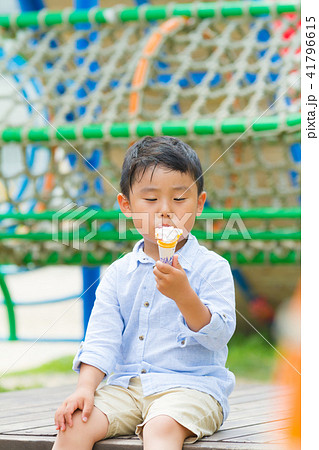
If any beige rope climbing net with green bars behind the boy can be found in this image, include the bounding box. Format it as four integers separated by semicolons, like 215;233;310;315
0;2;300;264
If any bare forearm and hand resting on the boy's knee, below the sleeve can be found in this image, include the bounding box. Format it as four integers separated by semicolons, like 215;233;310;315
55;363;105;431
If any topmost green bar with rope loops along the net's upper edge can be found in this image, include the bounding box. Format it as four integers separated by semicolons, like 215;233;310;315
0;0;300;28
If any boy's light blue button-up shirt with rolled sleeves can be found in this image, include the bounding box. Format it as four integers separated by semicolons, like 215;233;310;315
73;234;236;420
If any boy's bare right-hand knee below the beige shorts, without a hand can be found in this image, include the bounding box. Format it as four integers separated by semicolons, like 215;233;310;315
143;415;195;450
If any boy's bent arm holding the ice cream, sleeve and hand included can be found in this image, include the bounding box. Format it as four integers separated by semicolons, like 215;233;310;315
154;255;236;350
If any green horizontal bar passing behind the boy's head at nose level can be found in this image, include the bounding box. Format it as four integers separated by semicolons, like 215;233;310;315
0;207;301;221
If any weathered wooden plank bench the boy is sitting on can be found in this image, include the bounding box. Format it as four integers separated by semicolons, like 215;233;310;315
0;383;291;450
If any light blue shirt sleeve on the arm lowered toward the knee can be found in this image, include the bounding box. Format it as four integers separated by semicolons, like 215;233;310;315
73;263;124;375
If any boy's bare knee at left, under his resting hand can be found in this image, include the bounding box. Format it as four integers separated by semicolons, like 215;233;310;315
52;406;109;450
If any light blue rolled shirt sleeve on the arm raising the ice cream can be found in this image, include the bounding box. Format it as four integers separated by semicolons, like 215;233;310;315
178;260;236;351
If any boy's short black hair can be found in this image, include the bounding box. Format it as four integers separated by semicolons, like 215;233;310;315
120;136;204;199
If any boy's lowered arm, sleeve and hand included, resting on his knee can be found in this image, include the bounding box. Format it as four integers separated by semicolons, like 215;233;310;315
55;263;124;431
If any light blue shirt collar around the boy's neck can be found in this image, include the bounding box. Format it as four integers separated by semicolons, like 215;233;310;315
127;233;198;273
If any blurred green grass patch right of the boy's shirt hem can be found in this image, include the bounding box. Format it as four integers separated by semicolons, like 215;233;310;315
226;333;277;381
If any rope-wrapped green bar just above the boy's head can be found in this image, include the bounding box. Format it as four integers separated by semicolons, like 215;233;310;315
0;113;301;142
